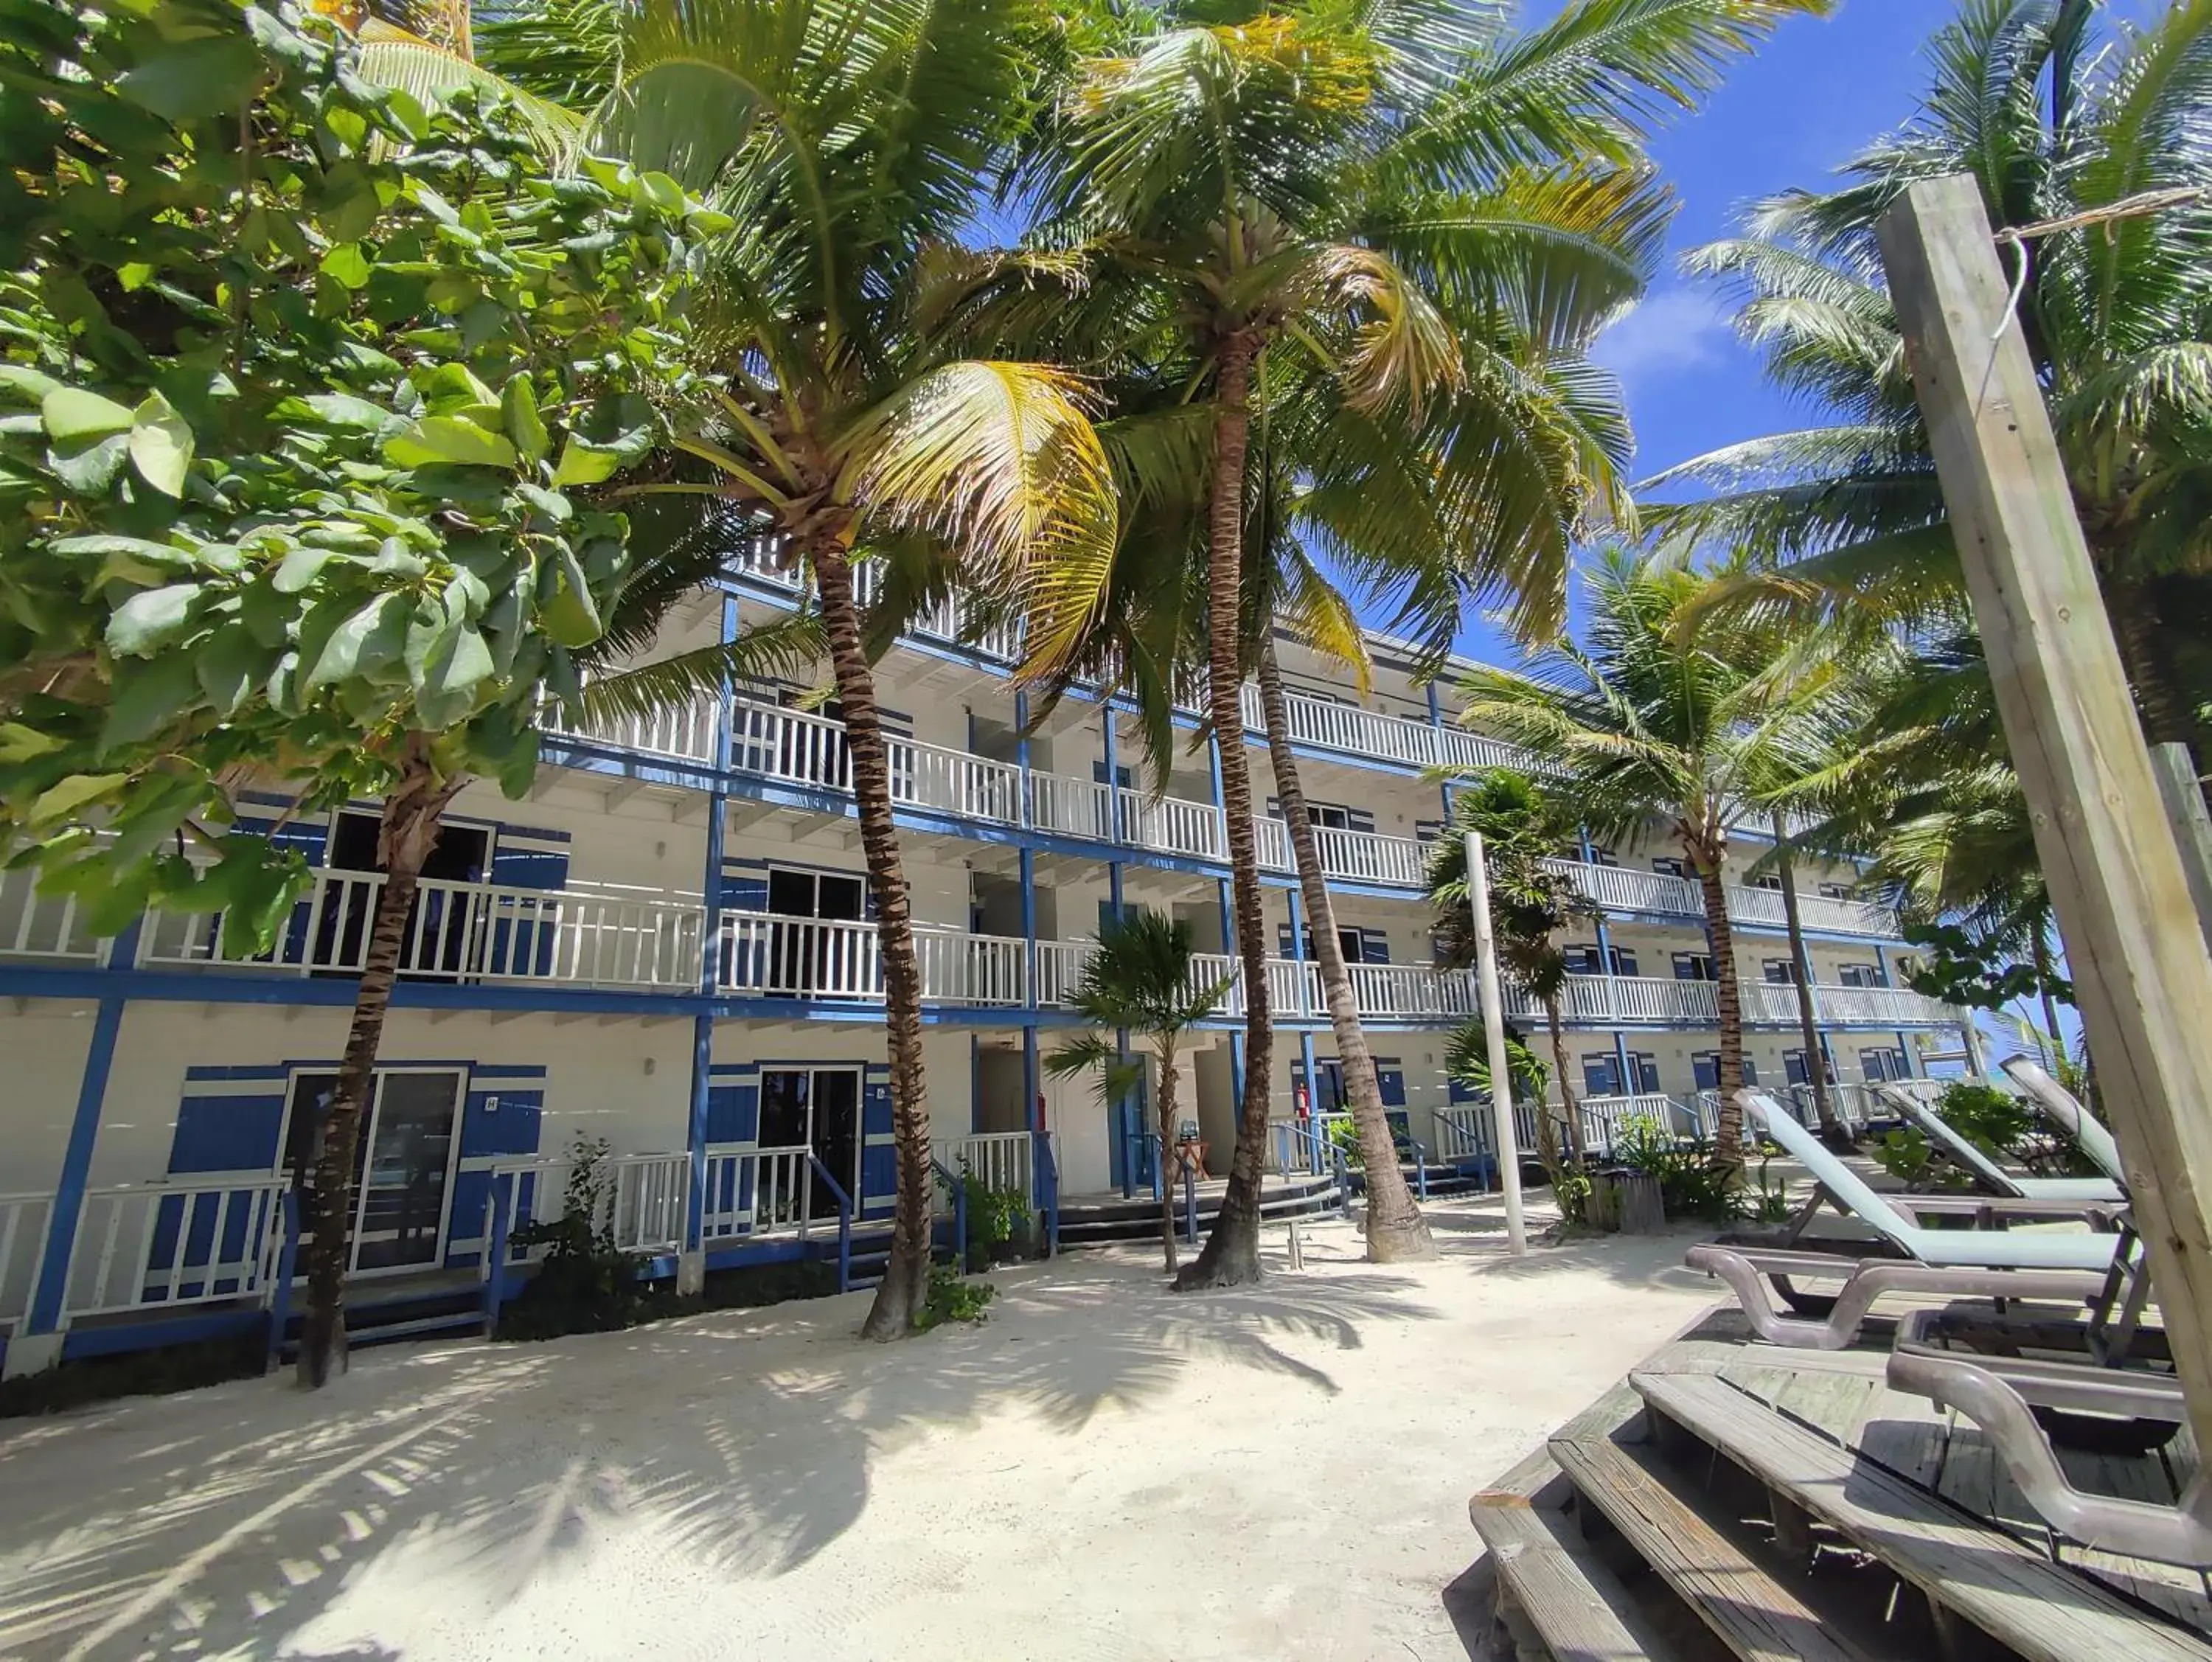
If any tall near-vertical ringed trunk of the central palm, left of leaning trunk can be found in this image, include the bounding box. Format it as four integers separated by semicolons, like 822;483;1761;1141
1175;334;1274;1288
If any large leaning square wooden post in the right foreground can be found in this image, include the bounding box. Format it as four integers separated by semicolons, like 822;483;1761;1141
1880;175;2212;1447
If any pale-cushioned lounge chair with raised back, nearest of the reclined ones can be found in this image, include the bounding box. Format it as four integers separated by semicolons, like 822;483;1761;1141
1686;1091;2121;1350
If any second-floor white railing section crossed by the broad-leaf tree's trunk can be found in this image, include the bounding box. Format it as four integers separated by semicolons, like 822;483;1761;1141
139;870;703;987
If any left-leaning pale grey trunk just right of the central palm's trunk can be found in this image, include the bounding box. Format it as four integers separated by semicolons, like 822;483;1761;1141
1259;633;1436;1264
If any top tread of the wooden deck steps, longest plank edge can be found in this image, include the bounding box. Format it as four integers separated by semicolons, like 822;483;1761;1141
1630;1374;2212;1662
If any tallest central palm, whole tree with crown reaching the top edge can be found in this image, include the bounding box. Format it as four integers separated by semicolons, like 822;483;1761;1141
1020;0;1827;1286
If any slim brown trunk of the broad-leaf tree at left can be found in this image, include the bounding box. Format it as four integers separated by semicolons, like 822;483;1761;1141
299;732;467;1390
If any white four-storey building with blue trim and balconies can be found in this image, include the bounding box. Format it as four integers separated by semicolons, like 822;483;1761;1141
0;569;1960;1372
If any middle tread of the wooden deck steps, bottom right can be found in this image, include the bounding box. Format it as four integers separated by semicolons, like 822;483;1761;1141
1551;1433;1865;1662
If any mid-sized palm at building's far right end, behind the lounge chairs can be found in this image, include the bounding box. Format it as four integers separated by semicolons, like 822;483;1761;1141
1462;551;1851;1171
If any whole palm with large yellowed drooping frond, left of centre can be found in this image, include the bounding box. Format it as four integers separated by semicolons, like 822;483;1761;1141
442;0;1117;1339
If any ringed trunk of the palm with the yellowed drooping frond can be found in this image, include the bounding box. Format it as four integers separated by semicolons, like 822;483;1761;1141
812;544;929;1339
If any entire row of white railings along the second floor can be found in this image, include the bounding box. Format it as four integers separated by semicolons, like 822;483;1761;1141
0;870;1962;1029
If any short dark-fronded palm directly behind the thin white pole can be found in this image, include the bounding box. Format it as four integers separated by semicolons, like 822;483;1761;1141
1429;768;1593;1189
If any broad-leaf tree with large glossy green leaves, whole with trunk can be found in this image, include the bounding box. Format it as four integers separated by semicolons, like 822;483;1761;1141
0;0;723;1383
